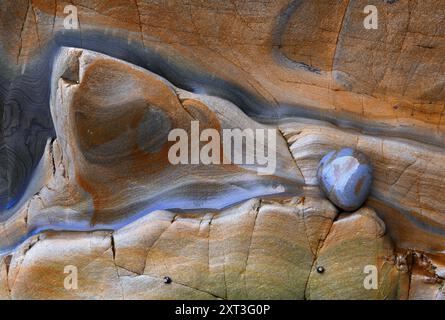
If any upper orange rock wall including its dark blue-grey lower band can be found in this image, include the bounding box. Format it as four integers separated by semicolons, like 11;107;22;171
0;0;445;207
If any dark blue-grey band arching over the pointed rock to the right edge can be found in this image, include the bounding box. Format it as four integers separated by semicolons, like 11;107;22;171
0;26;445;220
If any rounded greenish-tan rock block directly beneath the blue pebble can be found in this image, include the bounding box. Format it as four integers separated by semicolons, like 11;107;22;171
307;208;409;299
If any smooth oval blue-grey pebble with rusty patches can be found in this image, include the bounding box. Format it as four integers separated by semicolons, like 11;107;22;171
317;148;372;211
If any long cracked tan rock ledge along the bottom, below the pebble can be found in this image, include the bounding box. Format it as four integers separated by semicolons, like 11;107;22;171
0;198;408;299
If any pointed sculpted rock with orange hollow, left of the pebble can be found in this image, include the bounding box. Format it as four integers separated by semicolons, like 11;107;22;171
0;48;303;251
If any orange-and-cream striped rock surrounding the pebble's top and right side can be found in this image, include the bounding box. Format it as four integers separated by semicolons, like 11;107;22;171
280;122;445;253
